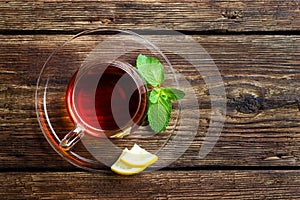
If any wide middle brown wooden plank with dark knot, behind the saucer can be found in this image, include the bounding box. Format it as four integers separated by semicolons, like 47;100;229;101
0;35;300;169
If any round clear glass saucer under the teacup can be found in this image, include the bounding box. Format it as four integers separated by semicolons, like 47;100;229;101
35;29;199;171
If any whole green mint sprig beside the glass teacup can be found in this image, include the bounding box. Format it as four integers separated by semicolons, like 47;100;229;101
136;54;185;133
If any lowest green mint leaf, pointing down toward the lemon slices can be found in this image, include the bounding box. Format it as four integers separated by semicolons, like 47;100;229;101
148;103;171;133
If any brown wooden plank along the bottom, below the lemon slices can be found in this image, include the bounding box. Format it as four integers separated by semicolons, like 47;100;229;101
0;171;300;200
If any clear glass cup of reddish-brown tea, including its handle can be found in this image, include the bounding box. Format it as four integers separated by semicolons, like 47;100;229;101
60;61;146;150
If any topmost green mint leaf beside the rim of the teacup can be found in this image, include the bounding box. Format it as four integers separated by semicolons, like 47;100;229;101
136;54;165;87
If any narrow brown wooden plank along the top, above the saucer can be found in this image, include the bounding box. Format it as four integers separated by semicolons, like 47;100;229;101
0;0;300;32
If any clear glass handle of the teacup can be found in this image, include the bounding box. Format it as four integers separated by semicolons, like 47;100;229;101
59;126;84;151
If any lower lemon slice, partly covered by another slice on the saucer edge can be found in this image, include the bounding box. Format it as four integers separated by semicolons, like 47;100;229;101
111;148;146;175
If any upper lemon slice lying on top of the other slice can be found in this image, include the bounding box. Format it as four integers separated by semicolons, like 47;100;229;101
120;144;158;168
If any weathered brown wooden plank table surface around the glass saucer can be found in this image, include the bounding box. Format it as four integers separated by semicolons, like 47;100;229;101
0;0;300;199
